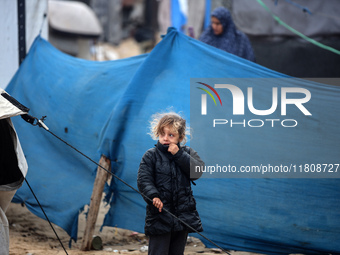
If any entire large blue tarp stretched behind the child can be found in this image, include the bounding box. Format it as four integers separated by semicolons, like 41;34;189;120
8;29;340;254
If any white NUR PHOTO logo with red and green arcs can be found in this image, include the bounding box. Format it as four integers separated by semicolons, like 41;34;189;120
196;79;312;127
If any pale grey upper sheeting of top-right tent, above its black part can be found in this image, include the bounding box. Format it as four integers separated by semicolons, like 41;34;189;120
232;0;340;37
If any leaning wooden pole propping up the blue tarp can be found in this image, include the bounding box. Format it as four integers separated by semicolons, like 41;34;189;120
80;155;111;251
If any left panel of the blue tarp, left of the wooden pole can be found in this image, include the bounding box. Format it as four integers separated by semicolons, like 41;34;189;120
6;37;146;240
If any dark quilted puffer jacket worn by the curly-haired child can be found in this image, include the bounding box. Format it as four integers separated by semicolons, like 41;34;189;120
137;142;204;236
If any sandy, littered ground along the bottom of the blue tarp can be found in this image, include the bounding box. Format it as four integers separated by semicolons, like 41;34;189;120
6;203;264;255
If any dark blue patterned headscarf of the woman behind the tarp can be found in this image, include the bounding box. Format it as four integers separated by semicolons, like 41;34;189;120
199;7;255;62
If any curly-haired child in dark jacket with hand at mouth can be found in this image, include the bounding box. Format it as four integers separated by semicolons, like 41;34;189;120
137;112;204;255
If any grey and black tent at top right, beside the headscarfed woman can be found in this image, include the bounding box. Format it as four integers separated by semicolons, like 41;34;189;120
232;0;340;78
